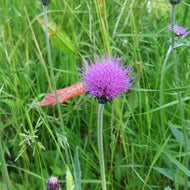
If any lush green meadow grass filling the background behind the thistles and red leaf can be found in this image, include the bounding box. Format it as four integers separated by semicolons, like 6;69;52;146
0;0;190;190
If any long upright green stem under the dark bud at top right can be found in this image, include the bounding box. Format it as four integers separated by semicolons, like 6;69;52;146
171;4;189;190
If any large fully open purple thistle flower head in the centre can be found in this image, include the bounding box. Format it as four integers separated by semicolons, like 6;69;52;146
79;54;134;104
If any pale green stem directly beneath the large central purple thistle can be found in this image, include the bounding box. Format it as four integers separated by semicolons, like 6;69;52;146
98;104;106;190
